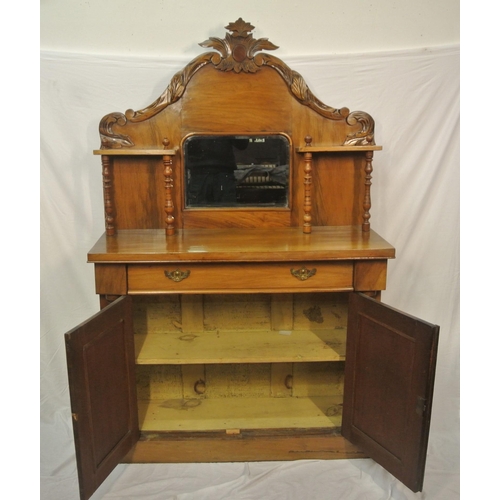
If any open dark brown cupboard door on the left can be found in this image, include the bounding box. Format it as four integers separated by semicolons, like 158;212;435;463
65;297;139;500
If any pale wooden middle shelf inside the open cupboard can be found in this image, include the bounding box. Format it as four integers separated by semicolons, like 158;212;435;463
134;328;346;365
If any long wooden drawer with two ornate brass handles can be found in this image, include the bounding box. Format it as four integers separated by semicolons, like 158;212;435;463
128;262;353;294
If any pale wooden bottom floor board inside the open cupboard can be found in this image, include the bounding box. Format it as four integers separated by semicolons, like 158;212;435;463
139;396;342;432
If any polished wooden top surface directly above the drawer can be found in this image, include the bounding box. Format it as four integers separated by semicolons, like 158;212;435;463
88;226;395;263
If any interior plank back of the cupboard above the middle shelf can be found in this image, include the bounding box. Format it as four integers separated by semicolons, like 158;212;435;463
133;292;348;334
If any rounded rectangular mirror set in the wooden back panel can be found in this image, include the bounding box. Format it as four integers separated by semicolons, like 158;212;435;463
184;135;290;208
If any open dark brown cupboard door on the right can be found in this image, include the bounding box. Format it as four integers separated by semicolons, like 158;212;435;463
342;293;439;491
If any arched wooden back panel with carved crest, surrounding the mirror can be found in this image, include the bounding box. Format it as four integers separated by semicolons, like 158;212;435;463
100;19;374;229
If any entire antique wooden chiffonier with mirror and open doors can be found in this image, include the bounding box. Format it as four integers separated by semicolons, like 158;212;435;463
66;19;438;499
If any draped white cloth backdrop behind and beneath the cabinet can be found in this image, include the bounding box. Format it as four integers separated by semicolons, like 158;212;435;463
41;46;460;500
